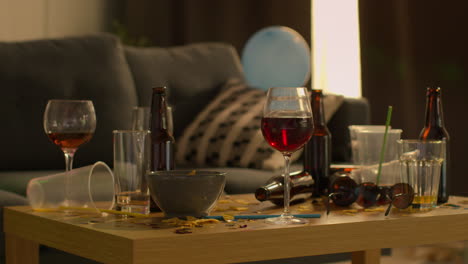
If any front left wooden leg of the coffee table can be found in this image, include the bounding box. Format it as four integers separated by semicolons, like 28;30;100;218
5;233;39;264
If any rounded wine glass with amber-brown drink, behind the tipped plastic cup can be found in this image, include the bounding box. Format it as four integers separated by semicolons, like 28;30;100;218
44;100;96;171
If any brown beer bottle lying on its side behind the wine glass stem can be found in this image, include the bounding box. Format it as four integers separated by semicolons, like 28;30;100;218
255;172;314;206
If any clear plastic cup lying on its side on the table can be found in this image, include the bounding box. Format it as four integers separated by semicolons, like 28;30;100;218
26;161;115;211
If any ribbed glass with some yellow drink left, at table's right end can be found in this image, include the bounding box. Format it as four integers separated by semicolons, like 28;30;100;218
397;140;446;210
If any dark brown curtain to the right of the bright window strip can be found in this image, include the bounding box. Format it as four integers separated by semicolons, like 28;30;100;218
359;0;468;195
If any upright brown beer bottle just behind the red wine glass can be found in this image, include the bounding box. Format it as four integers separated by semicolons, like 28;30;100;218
304;89;331;197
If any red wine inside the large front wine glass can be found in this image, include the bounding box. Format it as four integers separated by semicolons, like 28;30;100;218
262;117;313;153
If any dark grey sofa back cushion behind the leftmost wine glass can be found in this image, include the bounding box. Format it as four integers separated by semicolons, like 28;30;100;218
0;34;137;170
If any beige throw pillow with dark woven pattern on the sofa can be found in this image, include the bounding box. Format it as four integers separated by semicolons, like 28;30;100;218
176;80;292;170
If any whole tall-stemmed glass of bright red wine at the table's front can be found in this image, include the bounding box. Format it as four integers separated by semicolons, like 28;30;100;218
261;87;313;224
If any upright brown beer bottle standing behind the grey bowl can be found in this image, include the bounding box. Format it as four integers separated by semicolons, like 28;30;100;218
149;87;175;212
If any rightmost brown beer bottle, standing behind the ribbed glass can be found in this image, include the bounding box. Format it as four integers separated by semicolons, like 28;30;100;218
419;87;450;204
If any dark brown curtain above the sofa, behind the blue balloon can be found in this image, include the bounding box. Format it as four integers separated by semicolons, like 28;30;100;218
124;0;311;52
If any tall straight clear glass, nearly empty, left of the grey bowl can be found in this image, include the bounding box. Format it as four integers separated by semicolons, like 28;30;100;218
113;130;150;214
